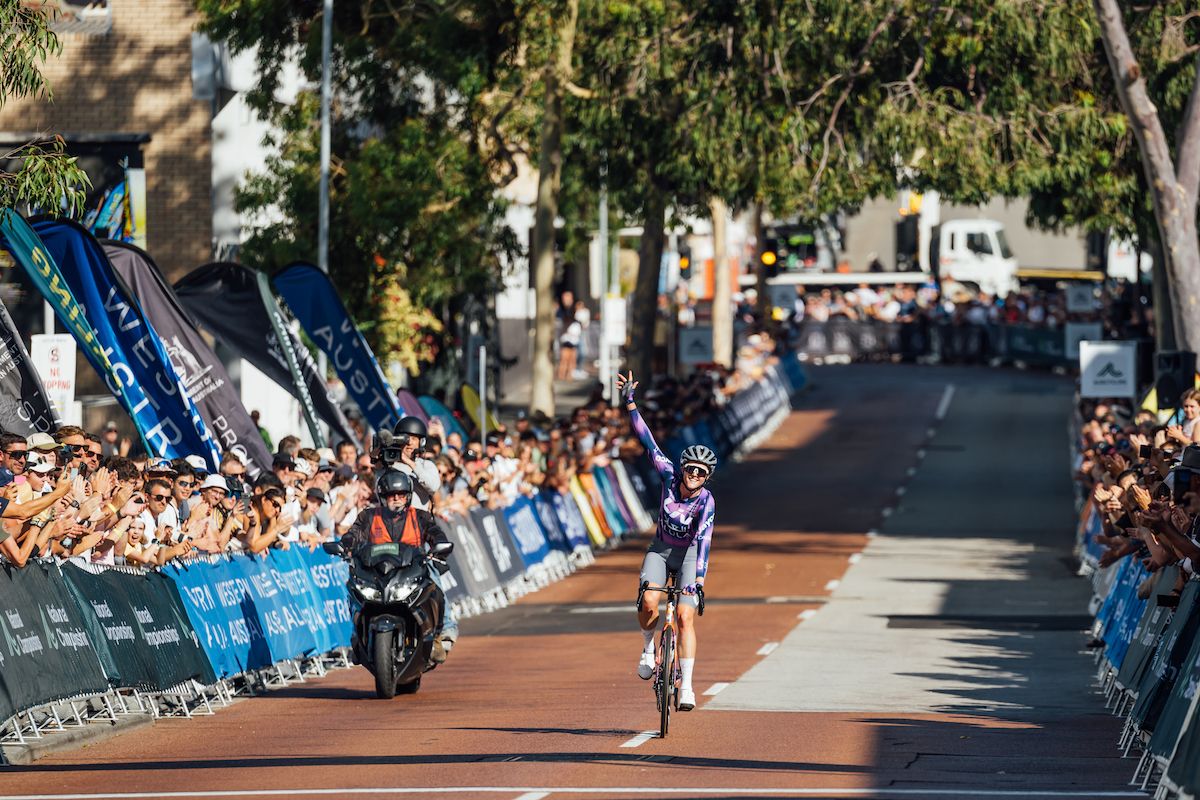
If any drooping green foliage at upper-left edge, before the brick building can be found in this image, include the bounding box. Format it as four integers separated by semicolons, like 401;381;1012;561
0;0;90;213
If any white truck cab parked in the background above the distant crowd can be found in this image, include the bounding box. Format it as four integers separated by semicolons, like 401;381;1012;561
929;219;1018;296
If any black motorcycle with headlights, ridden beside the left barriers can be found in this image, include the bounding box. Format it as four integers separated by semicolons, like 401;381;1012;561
323;541;454;698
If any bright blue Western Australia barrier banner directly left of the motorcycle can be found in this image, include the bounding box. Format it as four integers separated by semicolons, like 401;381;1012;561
163;548;350;676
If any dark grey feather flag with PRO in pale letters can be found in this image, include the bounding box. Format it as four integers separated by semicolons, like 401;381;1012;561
101;240;271;479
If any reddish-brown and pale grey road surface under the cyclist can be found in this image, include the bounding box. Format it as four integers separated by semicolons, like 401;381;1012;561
0;365;1139;800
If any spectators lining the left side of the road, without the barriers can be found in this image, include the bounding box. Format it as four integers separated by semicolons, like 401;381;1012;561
0;333;775;567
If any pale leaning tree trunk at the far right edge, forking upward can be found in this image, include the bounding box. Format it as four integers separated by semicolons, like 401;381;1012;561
1093;0;1200;351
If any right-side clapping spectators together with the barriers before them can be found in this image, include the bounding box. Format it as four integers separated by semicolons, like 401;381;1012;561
1072;390;1200;796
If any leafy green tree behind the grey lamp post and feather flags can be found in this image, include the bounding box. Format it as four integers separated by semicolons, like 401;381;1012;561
197;0;522;372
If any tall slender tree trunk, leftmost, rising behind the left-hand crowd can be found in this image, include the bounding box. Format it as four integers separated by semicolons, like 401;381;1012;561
529;0;580;416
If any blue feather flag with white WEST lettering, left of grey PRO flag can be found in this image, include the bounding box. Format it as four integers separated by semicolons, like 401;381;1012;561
21;219;221;470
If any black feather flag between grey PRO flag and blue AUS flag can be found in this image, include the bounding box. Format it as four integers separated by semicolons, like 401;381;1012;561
175;263;358;441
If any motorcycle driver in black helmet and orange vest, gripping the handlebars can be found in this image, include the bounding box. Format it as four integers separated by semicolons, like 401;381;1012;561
342;469;458;663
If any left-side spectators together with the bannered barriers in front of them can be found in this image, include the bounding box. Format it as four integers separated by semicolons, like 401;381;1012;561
0;337;805;742
